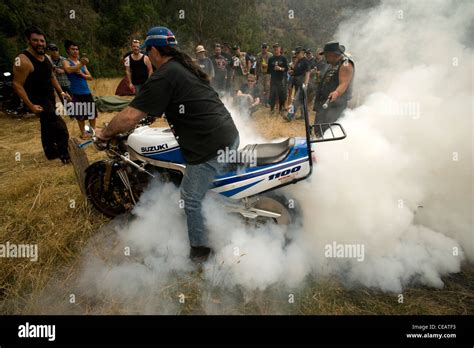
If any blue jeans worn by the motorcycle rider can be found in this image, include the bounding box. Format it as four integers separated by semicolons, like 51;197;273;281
181;136;239;247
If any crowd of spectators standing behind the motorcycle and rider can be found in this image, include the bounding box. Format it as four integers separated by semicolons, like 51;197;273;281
13;27;355;163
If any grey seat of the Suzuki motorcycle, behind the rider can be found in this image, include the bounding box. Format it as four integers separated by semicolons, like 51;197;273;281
239;138;296;166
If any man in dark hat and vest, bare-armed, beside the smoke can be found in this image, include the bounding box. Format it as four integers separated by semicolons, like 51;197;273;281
313;41;354;137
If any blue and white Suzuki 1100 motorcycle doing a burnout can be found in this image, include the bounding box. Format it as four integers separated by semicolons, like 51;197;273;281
73;86;346;225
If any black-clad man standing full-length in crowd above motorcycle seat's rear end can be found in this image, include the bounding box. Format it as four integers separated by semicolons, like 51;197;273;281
268;43;288;114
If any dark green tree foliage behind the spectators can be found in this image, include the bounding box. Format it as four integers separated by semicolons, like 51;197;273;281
0;0;378;76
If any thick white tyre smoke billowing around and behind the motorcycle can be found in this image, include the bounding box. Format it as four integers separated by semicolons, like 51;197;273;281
50;1;474;313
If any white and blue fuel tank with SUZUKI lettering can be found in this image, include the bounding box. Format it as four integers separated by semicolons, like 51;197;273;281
127;126;185;163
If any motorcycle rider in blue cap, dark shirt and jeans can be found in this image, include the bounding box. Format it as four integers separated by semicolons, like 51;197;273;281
97;27;239;262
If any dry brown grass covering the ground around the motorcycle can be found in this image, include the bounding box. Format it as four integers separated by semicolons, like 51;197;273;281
0;79;474;314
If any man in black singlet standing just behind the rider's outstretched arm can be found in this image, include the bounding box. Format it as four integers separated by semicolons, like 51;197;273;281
125;40;153;94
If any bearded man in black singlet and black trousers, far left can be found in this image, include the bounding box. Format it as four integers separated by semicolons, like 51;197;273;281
13;27;70;164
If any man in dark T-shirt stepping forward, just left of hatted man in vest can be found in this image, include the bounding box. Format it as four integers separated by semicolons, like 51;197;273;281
287;46;311;121
